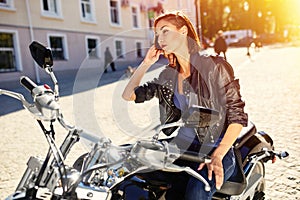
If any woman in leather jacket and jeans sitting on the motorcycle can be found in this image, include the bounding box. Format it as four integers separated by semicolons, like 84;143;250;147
122;12;247;200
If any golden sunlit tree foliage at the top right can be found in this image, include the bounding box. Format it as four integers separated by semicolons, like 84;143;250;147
196;0;300;38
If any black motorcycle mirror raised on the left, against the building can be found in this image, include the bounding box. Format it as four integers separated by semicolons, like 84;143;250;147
29;41;53;69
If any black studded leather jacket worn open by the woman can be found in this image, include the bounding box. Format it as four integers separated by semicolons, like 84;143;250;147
135;53;248;135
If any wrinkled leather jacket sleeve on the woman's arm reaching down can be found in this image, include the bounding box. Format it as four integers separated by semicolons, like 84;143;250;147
217;59;248;126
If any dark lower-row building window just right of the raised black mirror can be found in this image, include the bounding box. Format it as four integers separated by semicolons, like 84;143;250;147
49;36;66;60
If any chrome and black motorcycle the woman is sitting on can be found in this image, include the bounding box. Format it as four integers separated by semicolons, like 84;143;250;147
0;41;288;200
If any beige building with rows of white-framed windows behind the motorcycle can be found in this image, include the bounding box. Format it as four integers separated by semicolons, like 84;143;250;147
0;0;194;83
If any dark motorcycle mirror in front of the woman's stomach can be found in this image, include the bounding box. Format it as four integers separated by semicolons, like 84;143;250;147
182;105;219;128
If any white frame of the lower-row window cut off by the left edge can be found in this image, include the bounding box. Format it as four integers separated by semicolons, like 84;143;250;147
0;29;23;73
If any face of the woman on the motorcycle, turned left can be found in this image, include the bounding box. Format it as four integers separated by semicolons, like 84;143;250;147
155;19;187;54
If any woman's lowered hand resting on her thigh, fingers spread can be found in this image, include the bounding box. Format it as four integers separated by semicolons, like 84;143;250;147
198;154;224;190
